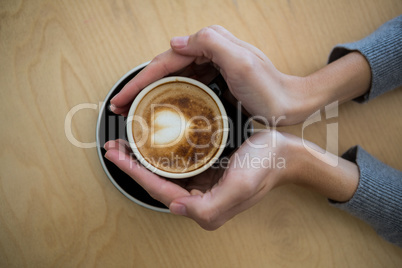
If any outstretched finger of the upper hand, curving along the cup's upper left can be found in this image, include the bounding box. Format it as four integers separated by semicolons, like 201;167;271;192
110;49;194;108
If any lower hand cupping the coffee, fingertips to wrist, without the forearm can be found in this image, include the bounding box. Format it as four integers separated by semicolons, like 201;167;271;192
105;131;298;230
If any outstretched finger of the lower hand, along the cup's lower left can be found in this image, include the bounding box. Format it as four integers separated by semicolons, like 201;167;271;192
105;149;190;206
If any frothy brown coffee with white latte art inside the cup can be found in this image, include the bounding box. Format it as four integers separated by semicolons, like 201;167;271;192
132;81;225;173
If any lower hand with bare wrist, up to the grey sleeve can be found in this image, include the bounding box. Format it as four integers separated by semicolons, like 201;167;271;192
105;131;359;230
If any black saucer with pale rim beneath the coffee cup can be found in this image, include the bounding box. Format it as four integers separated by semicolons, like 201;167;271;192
96;62;253;212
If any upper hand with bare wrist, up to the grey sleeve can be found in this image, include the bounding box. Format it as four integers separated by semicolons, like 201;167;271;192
111;26;371;126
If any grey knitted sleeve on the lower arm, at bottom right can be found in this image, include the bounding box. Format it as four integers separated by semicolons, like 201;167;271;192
330;146;402;247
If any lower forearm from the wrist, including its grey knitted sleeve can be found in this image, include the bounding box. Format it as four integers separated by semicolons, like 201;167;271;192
276;136;402;247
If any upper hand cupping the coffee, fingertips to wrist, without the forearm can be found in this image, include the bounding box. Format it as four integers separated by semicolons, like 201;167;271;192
111;26;311;125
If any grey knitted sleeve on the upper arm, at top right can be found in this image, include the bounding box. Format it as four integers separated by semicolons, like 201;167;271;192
328;15;402;102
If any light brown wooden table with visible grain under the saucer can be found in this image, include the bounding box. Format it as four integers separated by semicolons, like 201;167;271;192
0;0;402;267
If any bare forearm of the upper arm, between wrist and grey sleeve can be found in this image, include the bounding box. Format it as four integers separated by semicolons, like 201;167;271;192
280;52;371;125
